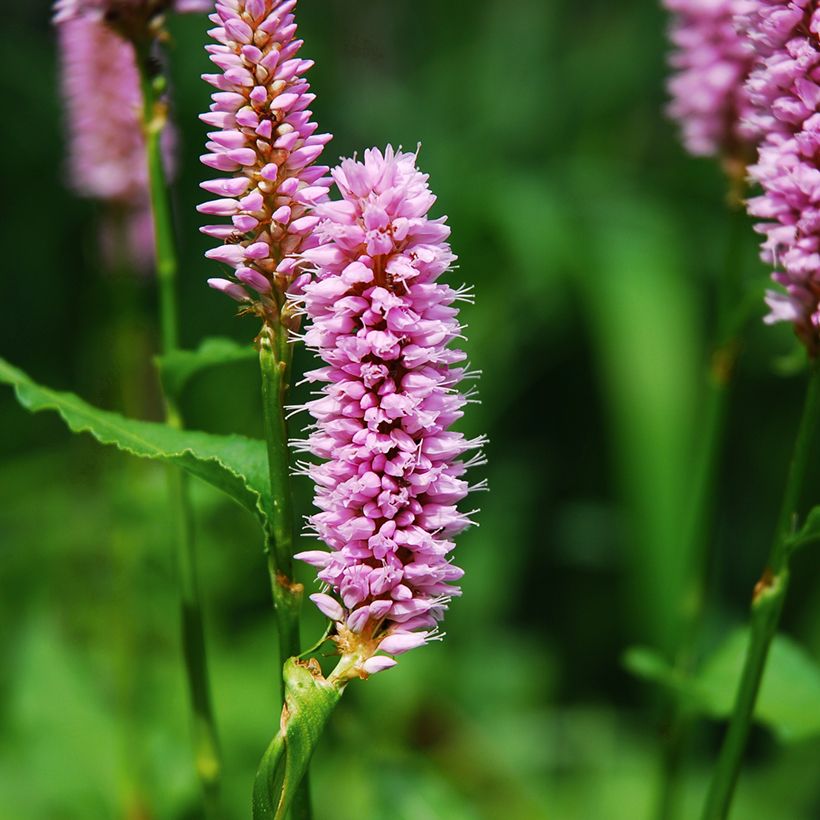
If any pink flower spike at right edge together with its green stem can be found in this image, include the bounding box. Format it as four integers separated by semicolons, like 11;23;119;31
703;0;820;820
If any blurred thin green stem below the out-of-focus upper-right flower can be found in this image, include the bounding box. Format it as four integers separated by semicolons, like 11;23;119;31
656;202;748;820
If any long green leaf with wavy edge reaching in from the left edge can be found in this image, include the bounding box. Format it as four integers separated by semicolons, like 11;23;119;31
0;359;270;524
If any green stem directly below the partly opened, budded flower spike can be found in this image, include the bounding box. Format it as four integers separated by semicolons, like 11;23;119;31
257;324;311;820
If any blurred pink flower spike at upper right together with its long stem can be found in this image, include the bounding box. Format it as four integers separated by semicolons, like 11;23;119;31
657;0;755;820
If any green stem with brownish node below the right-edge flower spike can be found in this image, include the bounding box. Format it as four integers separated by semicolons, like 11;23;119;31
702;362;820;820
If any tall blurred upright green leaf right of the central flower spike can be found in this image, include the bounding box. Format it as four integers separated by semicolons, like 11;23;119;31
578;195;701;649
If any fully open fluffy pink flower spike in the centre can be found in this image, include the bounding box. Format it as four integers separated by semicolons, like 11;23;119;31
297;147;483;675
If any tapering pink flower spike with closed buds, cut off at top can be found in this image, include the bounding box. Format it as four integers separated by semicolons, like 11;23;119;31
199;0;330;316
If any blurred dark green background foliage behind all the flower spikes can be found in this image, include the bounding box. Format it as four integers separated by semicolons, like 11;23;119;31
0;0;820;820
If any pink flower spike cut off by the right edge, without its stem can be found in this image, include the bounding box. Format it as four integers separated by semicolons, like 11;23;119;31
741;0;820;356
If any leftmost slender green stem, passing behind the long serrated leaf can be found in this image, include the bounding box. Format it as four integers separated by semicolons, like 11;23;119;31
136;45;222;818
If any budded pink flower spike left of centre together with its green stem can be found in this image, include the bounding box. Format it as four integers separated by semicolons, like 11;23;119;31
199;0;330;818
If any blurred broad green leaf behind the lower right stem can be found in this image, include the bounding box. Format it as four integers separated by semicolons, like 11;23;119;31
696;629;820;741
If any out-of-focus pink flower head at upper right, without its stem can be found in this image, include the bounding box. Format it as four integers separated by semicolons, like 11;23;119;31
664;0;754;157
